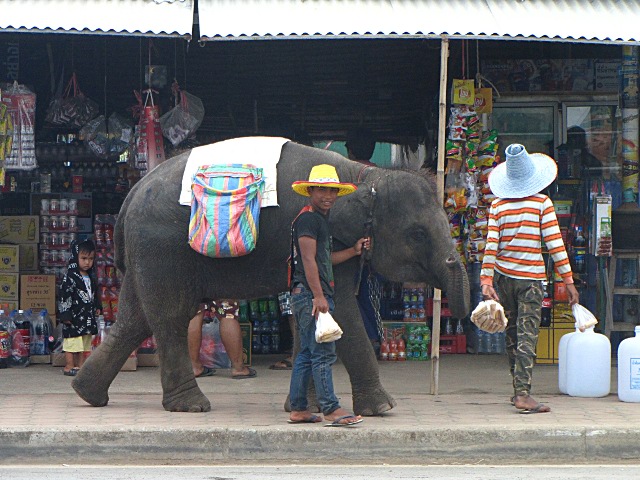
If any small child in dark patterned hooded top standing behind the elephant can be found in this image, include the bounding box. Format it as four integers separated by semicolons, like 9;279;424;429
58;240;102;377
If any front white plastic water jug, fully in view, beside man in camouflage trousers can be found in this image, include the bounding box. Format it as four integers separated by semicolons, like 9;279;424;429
567;327;611;397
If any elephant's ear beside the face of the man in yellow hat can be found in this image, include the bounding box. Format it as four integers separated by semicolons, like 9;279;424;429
329;183;372;250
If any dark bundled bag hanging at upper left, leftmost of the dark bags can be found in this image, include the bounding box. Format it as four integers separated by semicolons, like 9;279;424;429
45;72;98;129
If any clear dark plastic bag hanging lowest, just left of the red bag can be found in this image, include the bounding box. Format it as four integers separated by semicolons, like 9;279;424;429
80;112;133;158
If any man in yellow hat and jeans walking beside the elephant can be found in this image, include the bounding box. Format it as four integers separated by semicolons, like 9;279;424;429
289;164;369;427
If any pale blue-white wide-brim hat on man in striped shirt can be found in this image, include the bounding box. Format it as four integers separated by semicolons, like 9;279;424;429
489;143;558;198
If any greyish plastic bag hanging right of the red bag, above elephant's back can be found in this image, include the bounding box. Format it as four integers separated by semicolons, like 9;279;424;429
160;82;204;147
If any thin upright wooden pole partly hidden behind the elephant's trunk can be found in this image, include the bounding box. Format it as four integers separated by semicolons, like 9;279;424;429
431;36;449;395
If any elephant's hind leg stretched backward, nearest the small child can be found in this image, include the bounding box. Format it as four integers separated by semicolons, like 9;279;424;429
71;277;151;407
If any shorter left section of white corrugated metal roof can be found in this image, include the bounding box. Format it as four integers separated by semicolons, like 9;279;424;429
0;0;194;38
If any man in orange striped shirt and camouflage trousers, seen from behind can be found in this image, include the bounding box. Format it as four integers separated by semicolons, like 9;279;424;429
480;144;579;413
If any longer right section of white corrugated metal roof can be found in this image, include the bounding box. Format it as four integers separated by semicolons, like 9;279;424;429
198;0;640;43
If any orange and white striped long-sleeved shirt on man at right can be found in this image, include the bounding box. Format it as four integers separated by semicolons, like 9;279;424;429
480;193;573;285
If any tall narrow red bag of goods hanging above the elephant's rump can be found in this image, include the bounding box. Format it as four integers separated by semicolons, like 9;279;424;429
134;89;165;174
